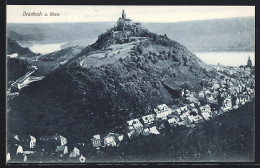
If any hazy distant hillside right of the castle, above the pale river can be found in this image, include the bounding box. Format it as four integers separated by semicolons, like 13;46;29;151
144;17;255;52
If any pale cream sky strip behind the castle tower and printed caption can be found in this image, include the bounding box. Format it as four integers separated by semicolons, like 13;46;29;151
7;5;255;23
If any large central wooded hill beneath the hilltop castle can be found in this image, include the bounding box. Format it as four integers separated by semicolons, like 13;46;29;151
8;18;210;141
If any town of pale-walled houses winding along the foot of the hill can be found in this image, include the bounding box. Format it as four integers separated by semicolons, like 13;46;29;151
6;58;255;163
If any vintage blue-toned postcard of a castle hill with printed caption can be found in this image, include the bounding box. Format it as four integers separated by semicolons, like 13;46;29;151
6;5;255;164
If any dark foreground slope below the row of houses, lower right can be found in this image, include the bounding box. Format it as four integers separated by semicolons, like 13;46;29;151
84;100;255;162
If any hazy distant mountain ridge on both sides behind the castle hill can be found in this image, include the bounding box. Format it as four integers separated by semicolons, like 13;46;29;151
7;17;255;52
